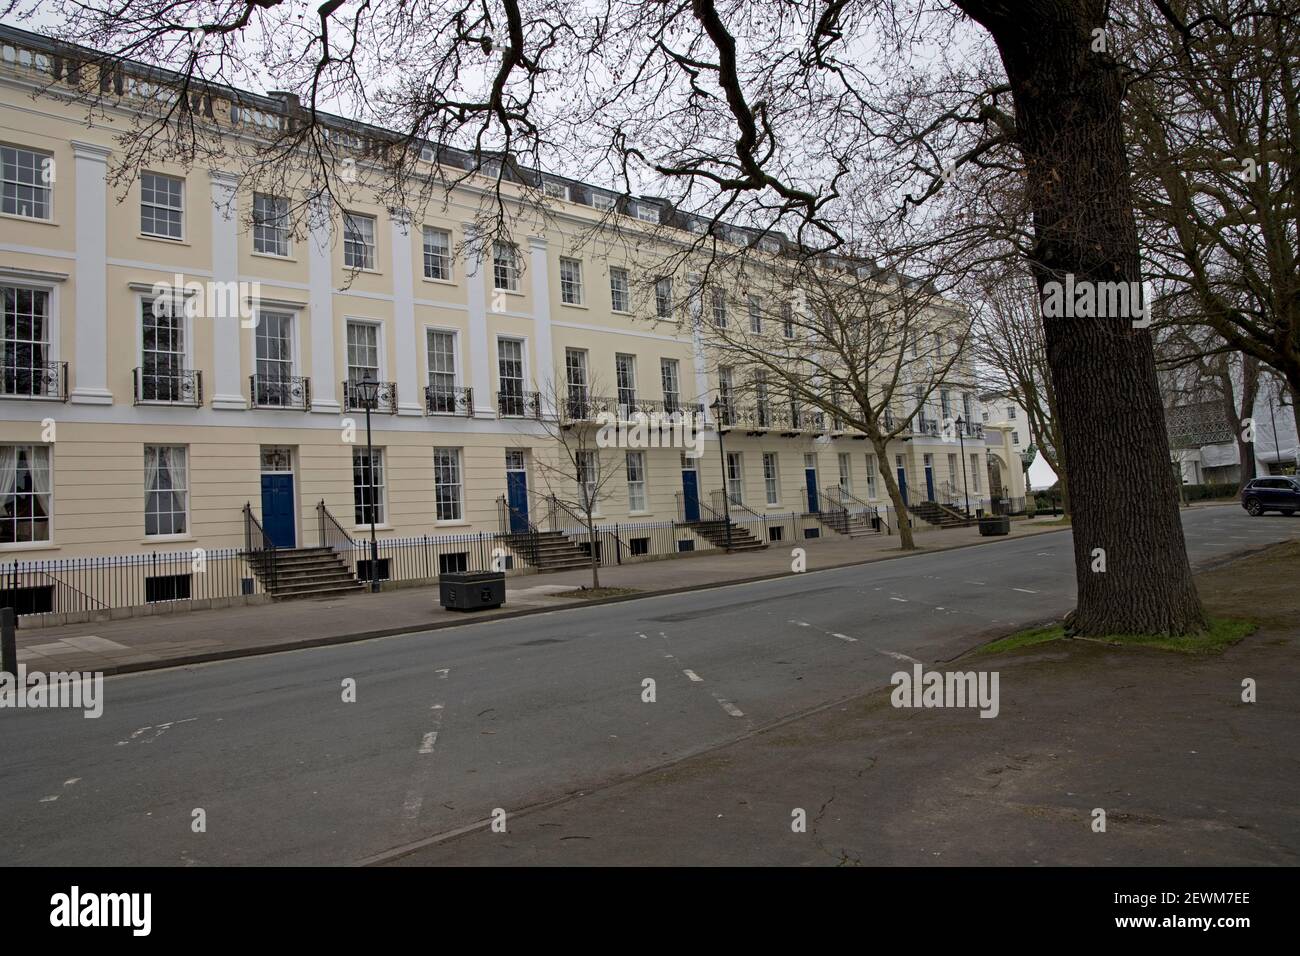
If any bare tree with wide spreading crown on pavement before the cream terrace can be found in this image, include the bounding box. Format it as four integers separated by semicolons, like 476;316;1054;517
693;255;974;550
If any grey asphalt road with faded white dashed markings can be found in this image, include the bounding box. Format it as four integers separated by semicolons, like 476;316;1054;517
0;505;1300;865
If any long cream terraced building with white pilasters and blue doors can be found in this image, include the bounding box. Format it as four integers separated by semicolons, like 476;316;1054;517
0;27;998;574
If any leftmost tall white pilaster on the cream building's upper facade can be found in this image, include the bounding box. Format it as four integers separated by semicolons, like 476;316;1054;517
70;139;113;405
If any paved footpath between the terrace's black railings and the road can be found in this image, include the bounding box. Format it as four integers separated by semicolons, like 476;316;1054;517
18;518;1061;674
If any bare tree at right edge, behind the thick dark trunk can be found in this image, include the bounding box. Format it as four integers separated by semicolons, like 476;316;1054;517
1118;0;1300;464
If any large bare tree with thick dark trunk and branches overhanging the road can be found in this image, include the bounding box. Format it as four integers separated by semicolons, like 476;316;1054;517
13;0;1227;635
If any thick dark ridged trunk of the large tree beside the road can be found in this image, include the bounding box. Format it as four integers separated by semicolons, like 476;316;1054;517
954;0;1205;636
